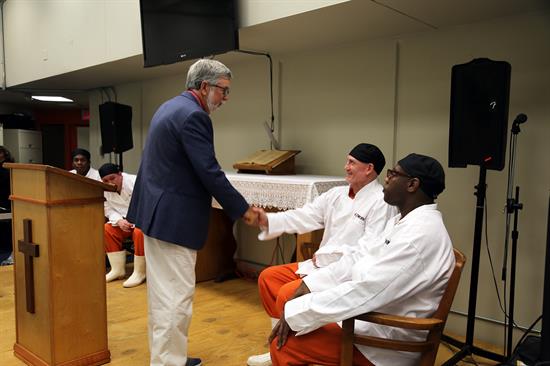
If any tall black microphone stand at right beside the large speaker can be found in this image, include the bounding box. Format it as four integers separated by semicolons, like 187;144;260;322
502;115;527;359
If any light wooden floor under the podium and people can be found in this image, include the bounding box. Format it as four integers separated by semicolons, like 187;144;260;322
0;266;496;366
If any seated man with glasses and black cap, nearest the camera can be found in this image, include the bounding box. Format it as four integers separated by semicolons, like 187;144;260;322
269;154;455;366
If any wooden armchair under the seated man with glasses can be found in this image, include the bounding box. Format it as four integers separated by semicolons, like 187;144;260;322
340;249;466;366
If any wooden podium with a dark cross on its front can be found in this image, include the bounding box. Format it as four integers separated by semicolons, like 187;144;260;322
4;164;115;366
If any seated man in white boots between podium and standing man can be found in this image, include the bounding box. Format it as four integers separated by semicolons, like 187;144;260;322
99;163;145;287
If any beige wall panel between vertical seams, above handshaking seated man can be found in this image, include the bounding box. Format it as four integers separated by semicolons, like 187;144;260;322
280;40;396;175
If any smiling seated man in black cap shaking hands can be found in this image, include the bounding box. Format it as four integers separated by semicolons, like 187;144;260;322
247;143;397;366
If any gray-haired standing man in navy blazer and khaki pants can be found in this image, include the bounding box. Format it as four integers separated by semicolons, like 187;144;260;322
127;59;257;366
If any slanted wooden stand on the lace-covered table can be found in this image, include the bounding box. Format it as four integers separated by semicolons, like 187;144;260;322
233;150;300;174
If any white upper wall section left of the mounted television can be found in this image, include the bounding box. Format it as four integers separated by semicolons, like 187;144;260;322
4;0;142;87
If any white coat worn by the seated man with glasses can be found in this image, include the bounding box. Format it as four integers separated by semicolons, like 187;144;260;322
285;204;455;366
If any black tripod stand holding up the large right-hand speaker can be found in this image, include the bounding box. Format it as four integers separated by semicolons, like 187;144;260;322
442;163;505;366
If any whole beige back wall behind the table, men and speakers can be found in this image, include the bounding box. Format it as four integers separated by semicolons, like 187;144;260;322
84;13;550;344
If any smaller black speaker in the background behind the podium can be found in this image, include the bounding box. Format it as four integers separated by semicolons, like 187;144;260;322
99;102;134;153
